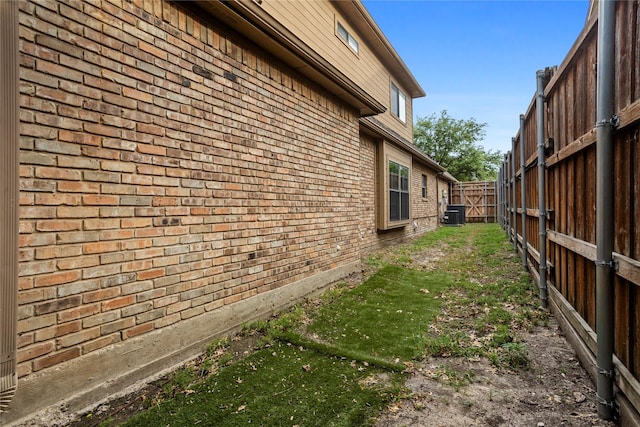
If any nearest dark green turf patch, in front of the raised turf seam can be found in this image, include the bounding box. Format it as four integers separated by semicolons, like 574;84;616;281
127;342;403;426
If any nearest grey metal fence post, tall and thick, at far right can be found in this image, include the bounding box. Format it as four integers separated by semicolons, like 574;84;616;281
596;0;616;419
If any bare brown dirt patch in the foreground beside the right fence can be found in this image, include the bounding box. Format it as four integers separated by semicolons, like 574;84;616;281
375;318;615;427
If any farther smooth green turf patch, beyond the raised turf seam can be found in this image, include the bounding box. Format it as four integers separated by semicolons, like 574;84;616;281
306;265;453;361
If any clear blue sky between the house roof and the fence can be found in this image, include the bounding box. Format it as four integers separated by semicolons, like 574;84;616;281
363;0;589;153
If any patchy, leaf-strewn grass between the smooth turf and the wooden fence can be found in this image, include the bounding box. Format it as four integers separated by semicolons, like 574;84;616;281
418;224;548;369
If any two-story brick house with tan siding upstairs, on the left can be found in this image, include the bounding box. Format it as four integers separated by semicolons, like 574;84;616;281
0;0;453;423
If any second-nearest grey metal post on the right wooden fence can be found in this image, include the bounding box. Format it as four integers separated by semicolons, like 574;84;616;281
536;70;548;308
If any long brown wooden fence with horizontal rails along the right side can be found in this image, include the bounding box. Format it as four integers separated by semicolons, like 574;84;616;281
500;0;640;420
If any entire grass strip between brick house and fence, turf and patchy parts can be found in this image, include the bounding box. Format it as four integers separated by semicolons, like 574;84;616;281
119;224;546;426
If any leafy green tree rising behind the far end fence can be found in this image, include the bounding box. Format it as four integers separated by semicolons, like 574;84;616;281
413;110;503;181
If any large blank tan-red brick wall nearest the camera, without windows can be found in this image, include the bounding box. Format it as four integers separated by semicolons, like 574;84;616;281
18;0;361;377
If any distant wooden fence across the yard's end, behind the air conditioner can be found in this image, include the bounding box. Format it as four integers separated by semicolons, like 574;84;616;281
450;181;498;222
